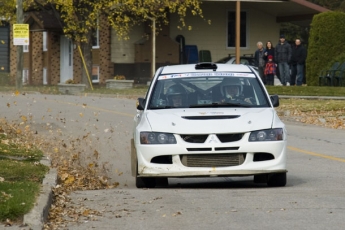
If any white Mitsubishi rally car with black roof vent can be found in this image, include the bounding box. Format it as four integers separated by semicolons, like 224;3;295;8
131;63;287;188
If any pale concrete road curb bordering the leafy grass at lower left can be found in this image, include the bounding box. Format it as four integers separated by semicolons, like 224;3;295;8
23;158;57;230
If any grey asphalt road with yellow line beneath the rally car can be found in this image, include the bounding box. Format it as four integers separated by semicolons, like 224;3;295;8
0;94;345;229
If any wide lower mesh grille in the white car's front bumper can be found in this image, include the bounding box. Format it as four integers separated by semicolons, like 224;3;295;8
180;153;246;168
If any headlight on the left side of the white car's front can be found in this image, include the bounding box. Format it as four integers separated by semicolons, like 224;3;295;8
140;132;176;144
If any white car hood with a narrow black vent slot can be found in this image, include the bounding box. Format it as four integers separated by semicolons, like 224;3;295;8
145;108;276;134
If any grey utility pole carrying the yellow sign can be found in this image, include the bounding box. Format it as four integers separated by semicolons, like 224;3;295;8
16;0;24;89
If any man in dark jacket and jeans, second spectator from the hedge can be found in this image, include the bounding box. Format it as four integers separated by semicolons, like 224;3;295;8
274;34;291;86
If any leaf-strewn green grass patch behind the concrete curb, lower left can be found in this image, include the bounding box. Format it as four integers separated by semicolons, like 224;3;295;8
0;127;49;221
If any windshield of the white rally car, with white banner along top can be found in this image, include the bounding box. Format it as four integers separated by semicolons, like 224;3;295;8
148;73;270;109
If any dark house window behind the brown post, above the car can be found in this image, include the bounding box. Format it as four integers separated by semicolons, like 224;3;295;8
227;11;247;48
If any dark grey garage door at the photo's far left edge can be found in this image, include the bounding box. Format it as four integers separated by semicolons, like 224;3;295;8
0;26;10;73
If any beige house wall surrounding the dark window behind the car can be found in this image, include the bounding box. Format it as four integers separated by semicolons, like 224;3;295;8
170;2;280;61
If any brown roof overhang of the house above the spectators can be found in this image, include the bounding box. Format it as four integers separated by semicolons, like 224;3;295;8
203;0;330;26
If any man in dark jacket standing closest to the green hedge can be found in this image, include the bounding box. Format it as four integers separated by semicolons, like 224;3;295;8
290;38;307;86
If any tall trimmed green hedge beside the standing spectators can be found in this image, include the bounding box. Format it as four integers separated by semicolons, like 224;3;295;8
306;12;345;86
